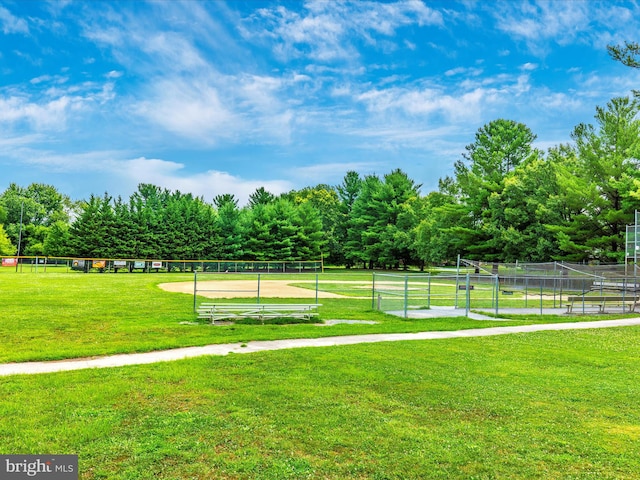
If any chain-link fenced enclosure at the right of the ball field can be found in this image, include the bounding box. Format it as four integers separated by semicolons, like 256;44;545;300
372;260;640;318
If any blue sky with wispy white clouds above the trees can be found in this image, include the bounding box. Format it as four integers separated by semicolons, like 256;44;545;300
0;0;640;203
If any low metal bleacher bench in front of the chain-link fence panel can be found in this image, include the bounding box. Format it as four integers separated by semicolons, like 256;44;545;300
197;303;322;324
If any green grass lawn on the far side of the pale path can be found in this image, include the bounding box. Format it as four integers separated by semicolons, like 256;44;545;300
0;269;572;363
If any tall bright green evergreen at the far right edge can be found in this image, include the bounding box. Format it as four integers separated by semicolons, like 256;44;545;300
556;98;640;262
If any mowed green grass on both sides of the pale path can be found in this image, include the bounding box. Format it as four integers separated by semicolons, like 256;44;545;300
0;273;640;479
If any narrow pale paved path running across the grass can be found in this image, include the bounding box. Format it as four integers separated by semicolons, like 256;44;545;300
0;318;640;376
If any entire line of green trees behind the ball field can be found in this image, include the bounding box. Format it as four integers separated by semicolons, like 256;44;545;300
0;43;640;268
